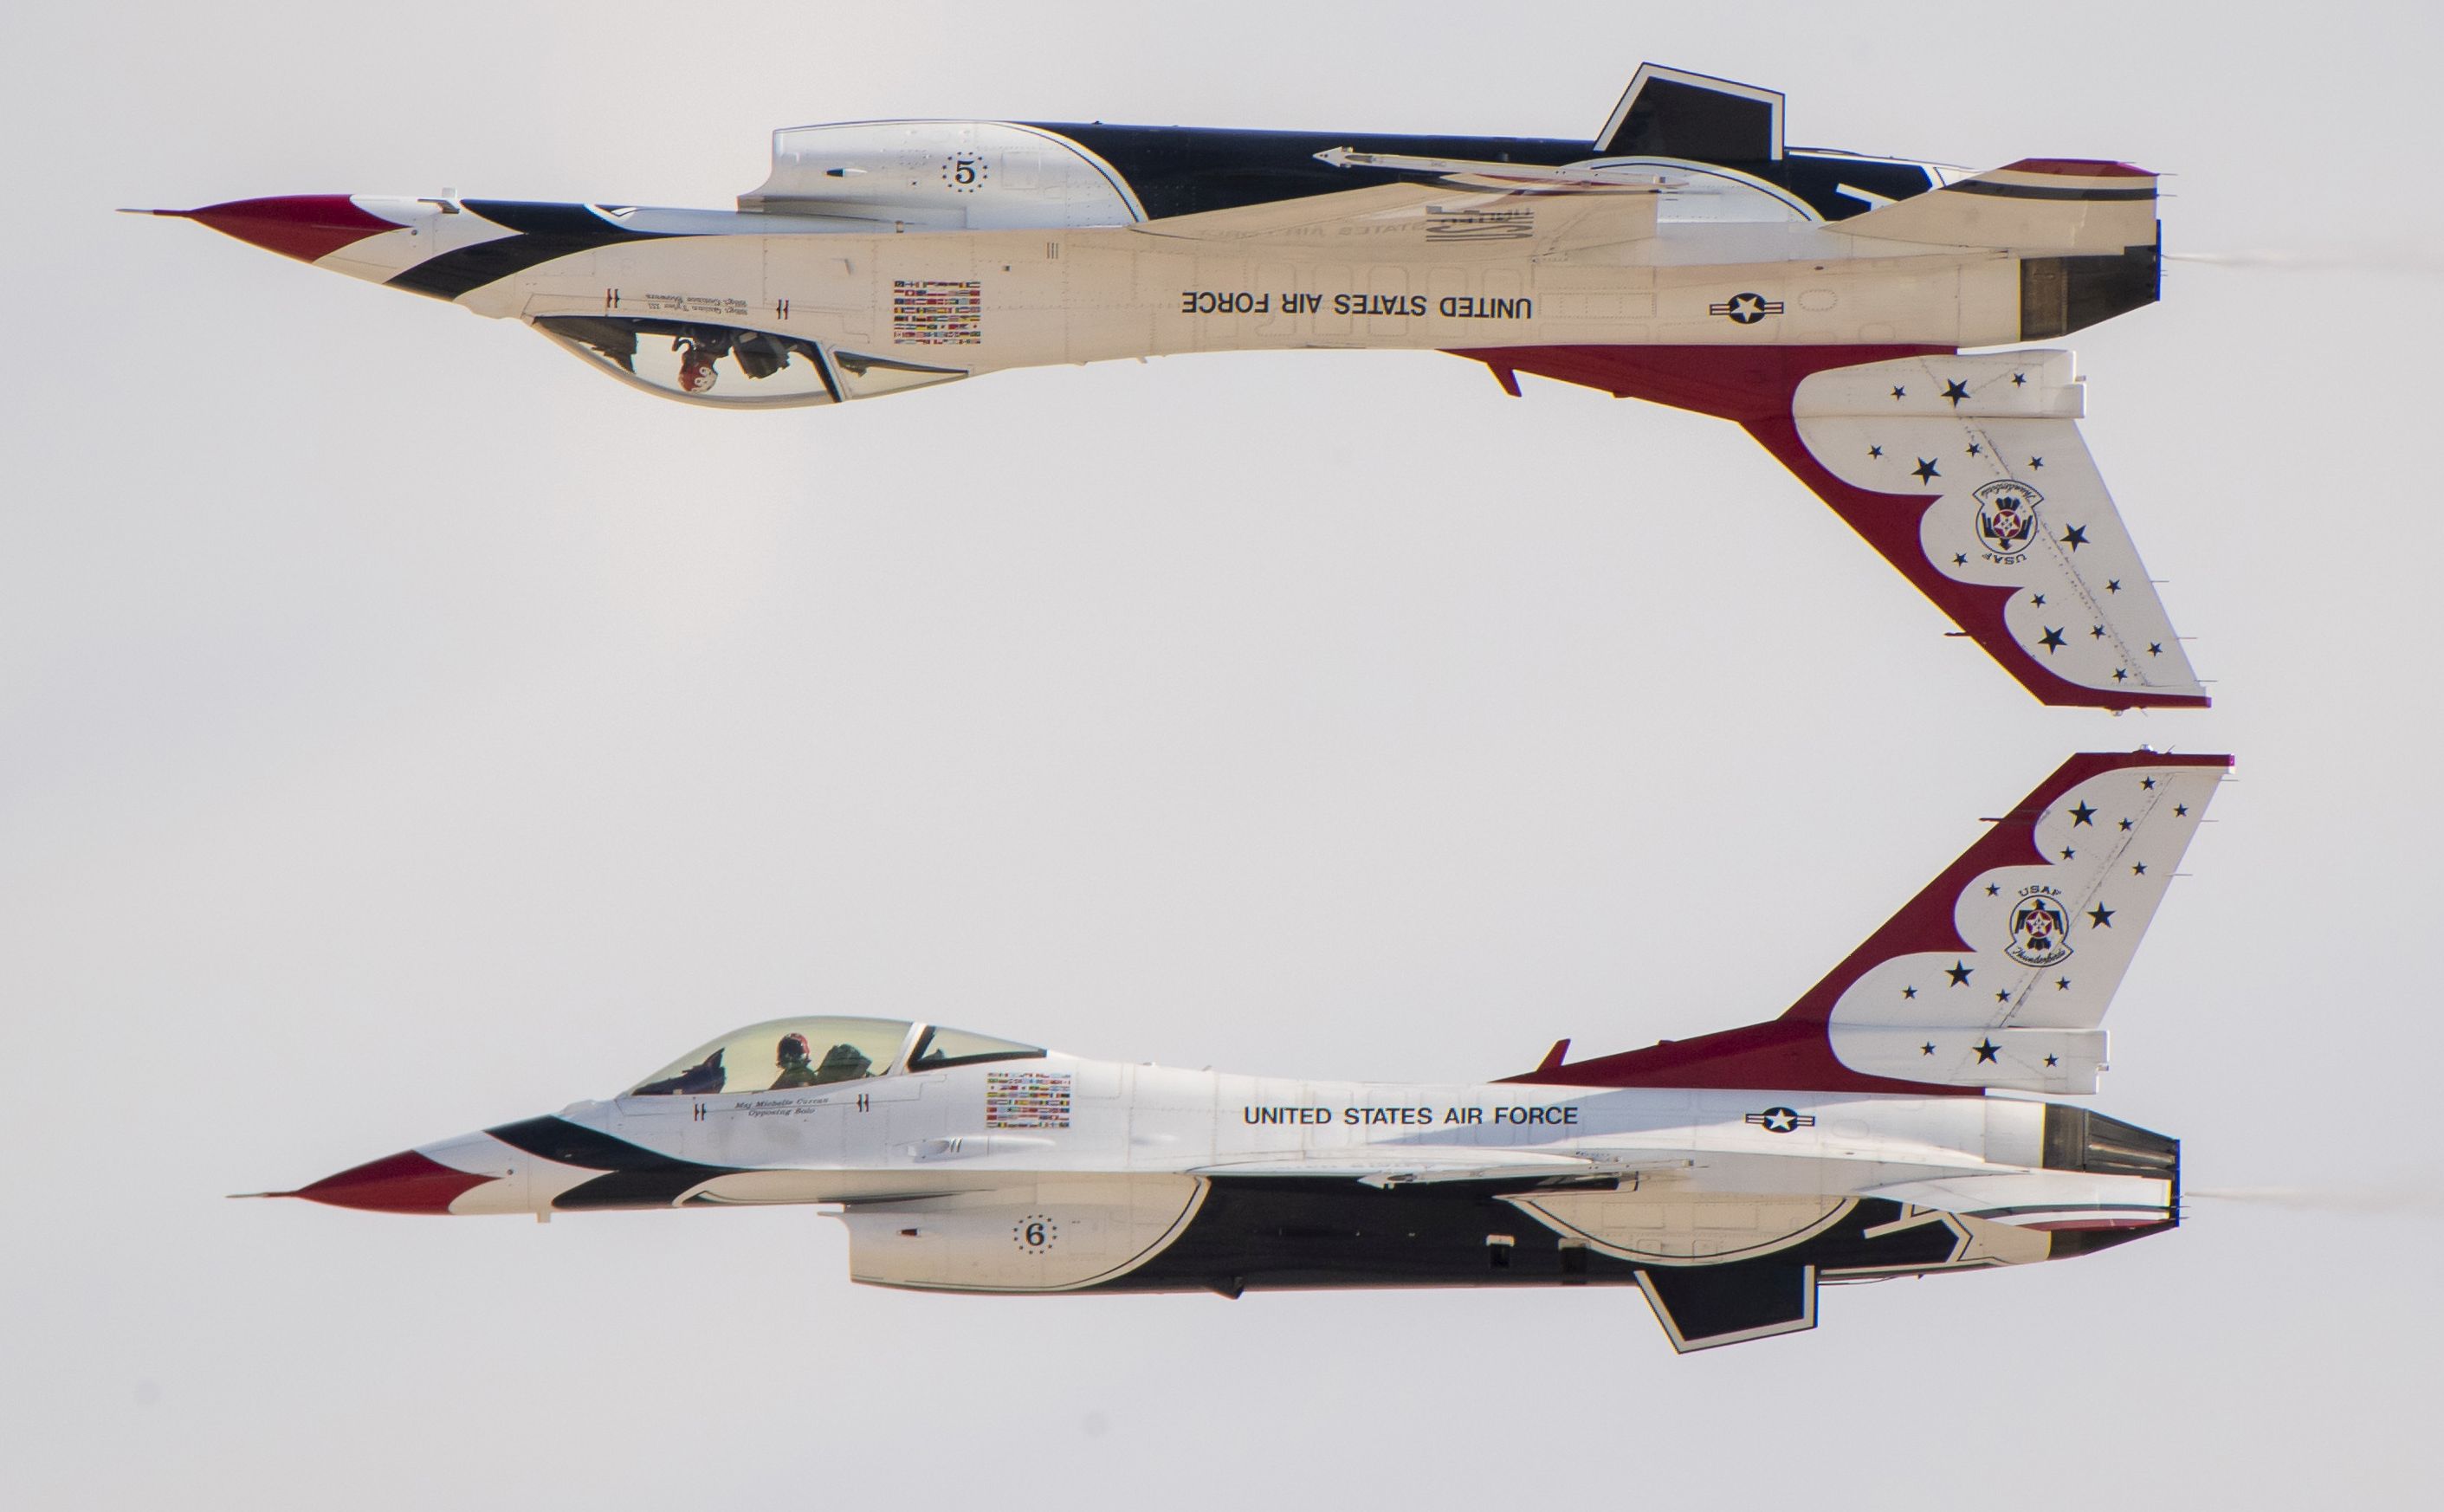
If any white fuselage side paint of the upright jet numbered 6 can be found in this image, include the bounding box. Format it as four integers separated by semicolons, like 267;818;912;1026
420;1056;2173;1226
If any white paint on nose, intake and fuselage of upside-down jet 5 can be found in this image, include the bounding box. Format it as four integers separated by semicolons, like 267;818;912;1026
323;122;2019;403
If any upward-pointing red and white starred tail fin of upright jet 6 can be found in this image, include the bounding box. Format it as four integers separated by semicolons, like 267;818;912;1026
1513;750;2231;1095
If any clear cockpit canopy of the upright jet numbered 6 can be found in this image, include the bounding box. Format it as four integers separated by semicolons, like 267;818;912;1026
628;1018;1044;1096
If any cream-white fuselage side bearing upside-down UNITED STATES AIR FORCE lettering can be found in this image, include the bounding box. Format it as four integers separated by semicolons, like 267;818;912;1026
481;217;2019;374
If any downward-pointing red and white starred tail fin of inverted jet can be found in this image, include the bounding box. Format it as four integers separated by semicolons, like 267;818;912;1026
1459;347;2207;708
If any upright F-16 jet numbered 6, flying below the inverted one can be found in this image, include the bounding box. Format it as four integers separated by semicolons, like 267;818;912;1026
268;750;2231;1351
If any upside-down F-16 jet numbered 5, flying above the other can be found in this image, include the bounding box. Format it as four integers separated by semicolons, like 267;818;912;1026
158;66;2207;708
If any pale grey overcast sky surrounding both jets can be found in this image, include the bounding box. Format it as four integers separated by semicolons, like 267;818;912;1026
0;0;2444;1509
